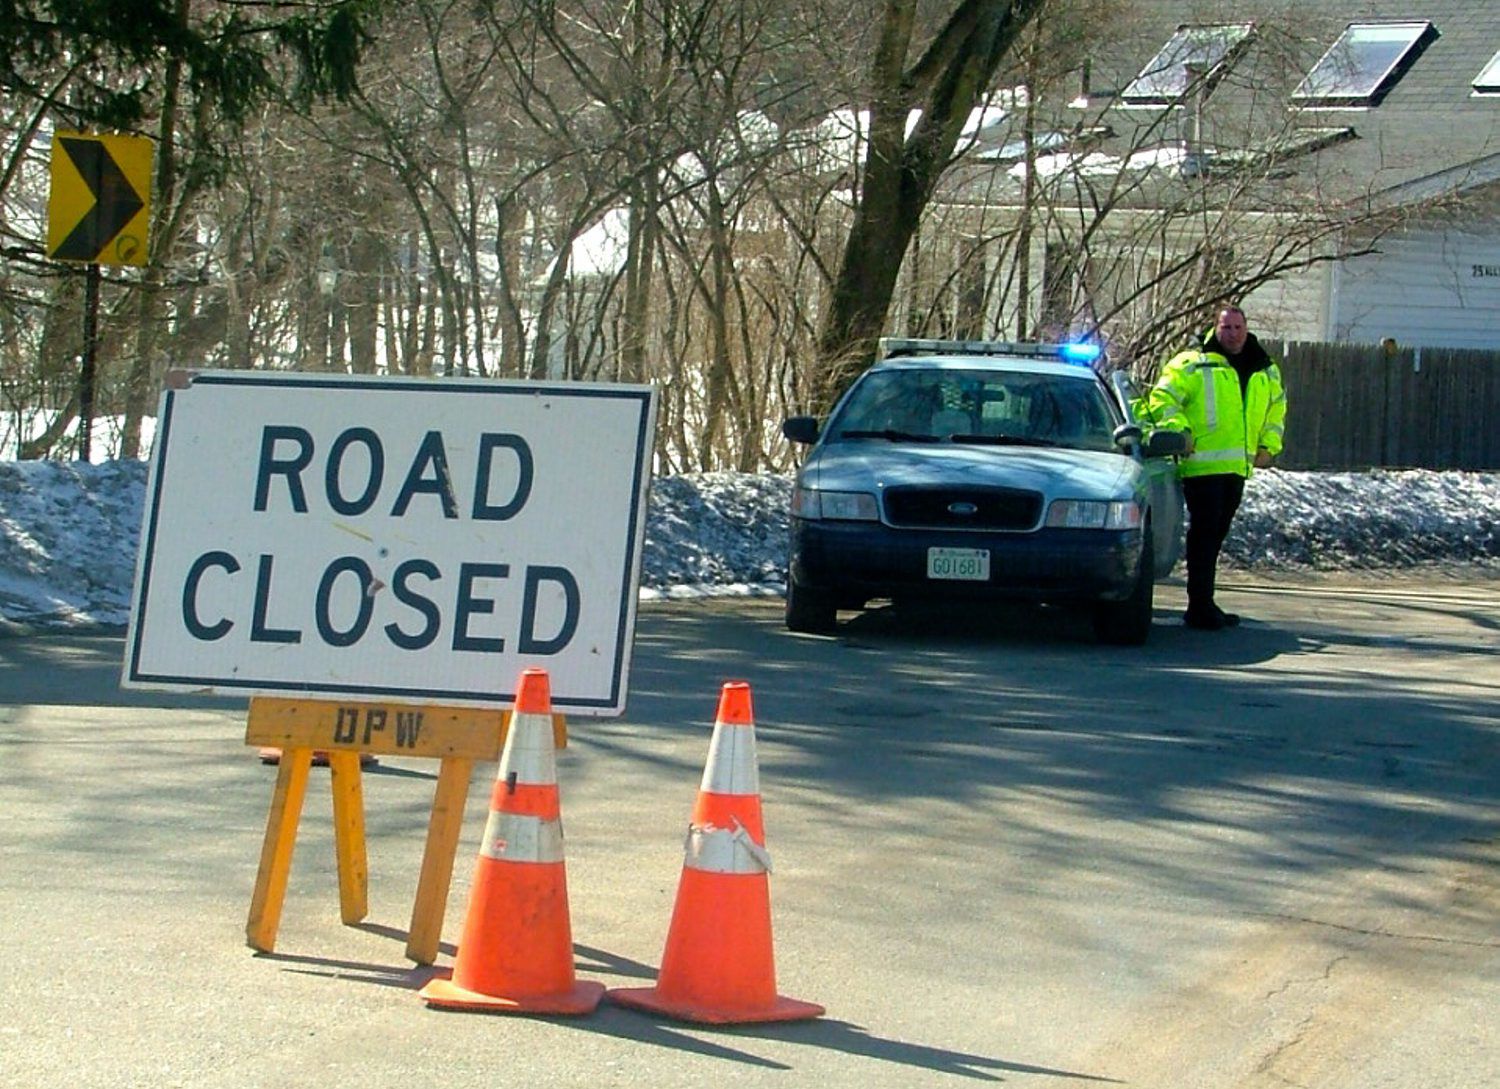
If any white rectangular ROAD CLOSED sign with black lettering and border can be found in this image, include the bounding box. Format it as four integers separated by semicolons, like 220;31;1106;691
122;372;656;716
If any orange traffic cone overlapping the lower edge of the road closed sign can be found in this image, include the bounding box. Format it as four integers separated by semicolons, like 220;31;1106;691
422;669;605;1014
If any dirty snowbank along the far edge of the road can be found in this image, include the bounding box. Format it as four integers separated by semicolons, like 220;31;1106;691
0;461;1500;627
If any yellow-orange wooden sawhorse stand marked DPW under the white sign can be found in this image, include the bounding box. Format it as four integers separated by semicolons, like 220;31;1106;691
245;696;567;965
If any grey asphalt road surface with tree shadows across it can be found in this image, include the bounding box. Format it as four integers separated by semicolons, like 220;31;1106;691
0;576;1500;1089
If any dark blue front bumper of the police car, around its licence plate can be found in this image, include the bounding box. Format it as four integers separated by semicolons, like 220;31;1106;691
789;518;1142;602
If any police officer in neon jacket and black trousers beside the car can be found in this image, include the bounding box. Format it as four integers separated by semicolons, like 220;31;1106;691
1148;306;1287;632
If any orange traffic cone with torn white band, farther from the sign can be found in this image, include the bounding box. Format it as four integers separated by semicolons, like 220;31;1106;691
609;681;824;1025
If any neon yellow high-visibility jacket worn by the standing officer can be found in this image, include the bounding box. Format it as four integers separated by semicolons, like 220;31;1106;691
1146;333;1287;477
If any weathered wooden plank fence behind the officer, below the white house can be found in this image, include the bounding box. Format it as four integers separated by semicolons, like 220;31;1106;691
1266;342;1500;470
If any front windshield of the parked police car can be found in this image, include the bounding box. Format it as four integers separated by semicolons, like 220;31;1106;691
828;368;1118;452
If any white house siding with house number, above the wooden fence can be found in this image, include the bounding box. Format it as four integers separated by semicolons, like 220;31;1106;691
1331;227;1500;350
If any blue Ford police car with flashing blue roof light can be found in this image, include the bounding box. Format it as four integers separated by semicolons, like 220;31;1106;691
782;339;1184;644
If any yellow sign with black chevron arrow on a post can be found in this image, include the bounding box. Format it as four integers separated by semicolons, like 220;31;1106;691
47;132;153;264
